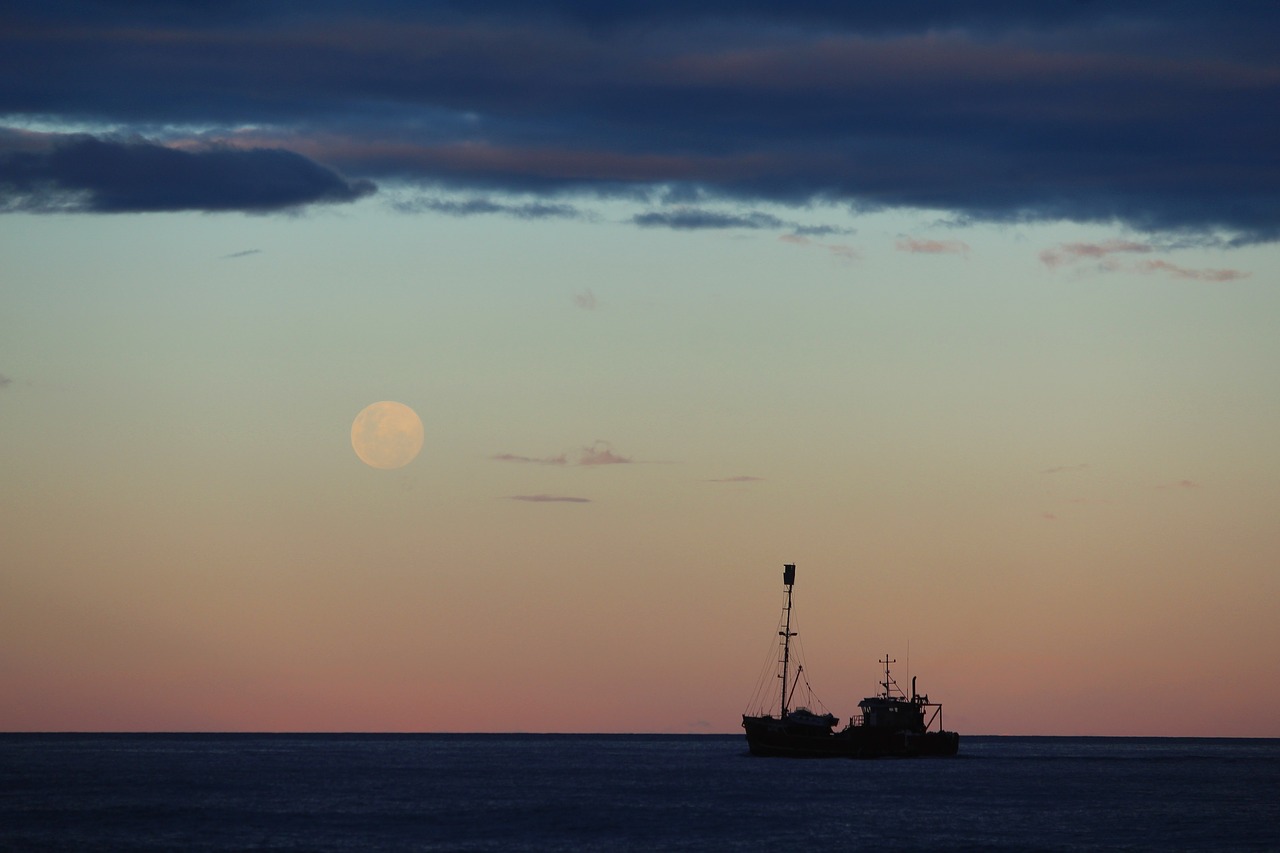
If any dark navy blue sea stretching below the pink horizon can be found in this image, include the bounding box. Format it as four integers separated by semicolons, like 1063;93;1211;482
0;734;1280;852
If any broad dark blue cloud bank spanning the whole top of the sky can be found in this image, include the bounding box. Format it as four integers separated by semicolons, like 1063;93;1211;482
0;0;1280;239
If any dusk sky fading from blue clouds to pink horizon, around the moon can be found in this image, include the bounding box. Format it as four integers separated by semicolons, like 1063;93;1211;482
0;0;1280;738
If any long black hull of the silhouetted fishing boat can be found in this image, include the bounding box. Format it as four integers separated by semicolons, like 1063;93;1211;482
742;717;960;758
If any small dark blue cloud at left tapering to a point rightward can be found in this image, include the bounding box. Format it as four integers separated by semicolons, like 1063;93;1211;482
0;133;375;213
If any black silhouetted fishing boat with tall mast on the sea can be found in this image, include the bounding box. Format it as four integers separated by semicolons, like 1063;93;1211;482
742;564;960;758
